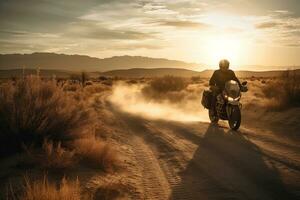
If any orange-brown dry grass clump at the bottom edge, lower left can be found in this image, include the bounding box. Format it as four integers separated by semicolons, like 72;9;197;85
8;176;92;200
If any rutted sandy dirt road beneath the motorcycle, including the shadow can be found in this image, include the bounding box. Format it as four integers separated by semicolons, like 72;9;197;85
97;92;300;200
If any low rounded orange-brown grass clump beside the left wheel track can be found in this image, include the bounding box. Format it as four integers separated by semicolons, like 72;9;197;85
74;138;117;171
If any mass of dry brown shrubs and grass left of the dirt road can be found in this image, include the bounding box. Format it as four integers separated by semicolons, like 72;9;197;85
0;76;118;200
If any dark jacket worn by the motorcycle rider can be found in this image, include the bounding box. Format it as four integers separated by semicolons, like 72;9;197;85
209;69;241;91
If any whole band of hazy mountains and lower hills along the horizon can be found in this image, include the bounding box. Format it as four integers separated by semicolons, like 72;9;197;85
0;53;300;78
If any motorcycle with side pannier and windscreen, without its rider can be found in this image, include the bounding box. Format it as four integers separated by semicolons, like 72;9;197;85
202;80;248;130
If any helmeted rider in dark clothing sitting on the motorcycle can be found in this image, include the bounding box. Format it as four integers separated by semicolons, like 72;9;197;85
209;59;242;111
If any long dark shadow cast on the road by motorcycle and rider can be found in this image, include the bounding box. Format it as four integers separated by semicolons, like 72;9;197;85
171;125;295;199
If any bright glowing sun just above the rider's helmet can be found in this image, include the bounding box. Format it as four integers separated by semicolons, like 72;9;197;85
206;36;241;65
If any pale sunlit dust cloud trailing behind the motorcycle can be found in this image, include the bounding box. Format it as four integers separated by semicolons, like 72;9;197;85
109;82;209;122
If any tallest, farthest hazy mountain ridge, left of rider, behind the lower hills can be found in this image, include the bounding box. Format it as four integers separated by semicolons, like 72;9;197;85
0;53;199;72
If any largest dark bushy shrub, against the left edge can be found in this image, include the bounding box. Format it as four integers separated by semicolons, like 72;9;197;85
0;77;93;155
